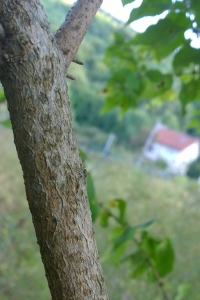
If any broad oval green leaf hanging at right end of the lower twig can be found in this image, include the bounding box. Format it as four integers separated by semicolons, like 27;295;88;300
155;238;174;277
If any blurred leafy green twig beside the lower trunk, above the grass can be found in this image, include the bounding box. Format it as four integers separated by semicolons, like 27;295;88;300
83;151;194;300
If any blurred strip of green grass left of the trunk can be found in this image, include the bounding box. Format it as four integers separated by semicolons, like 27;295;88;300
0;128;49;300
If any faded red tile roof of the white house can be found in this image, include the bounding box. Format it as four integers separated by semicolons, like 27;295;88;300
155;128;199;150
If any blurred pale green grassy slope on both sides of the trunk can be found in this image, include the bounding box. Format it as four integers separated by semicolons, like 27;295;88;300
0;130;200;300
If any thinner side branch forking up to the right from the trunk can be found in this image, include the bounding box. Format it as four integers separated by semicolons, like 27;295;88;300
56;0;103;68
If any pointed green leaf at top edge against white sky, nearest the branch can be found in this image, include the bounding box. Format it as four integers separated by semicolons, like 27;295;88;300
127;0;171;24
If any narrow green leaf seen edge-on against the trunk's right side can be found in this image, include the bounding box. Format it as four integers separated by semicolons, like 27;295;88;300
87;173;100;222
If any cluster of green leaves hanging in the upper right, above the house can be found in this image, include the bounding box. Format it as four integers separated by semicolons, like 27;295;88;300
104;0;200;131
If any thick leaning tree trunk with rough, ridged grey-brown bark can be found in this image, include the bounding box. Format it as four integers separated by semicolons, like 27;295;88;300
0;0;108;300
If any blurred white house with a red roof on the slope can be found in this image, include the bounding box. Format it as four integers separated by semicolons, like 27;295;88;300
143;122;199;174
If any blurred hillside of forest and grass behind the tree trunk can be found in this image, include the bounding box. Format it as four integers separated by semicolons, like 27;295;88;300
0;0;200;300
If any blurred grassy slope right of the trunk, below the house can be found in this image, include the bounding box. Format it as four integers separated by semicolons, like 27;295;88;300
93;157;200;300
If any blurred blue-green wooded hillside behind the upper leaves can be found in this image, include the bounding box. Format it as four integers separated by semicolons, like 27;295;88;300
0;0;193;144
